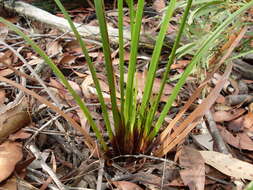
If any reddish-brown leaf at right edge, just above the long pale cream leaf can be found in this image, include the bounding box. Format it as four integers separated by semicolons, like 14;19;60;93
218;126;253;151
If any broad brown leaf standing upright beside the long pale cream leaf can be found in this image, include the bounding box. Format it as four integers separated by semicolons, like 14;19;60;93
179;146;205;190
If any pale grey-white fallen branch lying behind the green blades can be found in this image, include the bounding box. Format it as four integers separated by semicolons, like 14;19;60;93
0;0;174;47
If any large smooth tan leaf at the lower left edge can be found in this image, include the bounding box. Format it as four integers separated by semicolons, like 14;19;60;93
0;141;23;182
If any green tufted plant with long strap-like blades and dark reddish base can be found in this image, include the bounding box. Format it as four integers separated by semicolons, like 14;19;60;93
0;0;253;155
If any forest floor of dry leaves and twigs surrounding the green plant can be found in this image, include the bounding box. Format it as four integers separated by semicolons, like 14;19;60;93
0;0;253;190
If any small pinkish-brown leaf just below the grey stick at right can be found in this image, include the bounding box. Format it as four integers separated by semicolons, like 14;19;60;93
213;108;246;122
